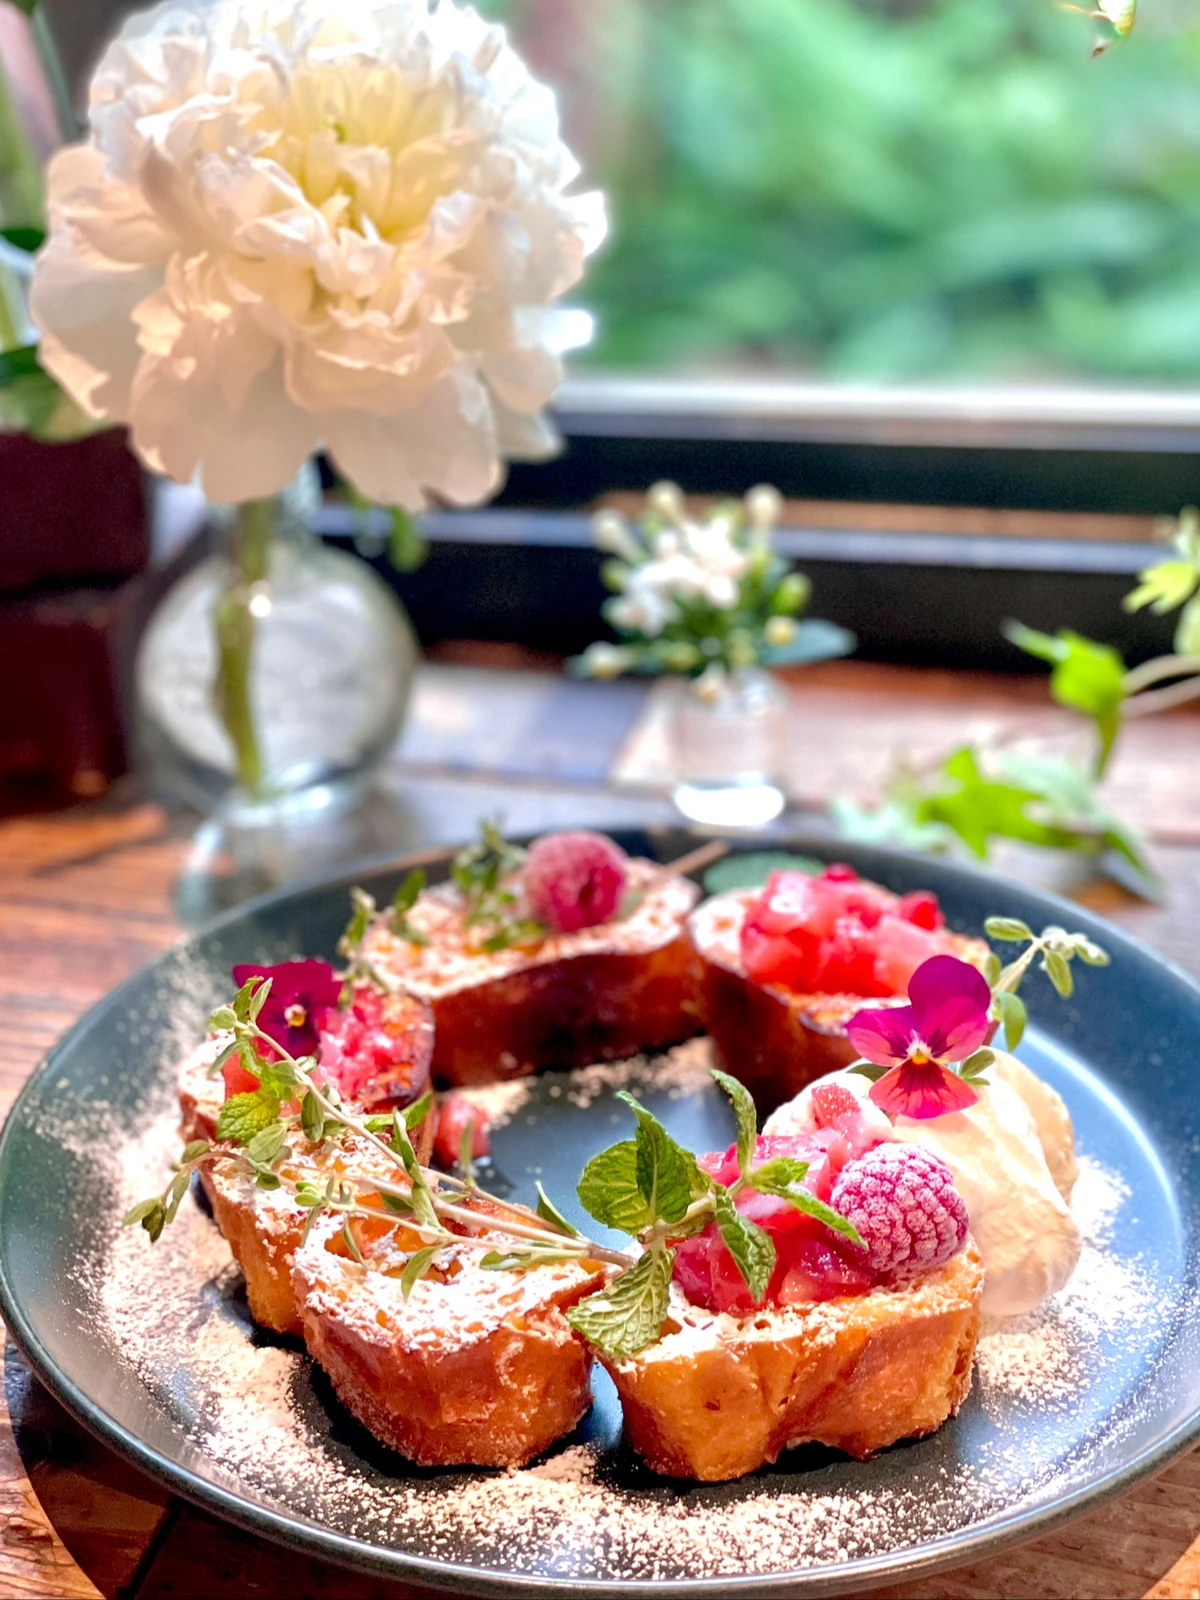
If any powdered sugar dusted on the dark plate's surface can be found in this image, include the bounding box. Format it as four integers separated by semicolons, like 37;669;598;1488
65;1040;1184;1581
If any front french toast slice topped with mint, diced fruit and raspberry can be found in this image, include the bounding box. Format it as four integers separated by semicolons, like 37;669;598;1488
597;1240;984;1482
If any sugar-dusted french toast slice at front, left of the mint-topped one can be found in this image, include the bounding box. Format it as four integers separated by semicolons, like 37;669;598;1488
293;1218;605;1467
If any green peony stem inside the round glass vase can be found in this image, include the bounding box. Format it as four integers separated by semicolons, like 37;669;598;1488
213;499;275;798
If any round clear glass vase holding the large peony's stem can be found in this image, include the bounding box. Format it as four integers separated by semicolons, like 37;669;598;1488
136;470;418;827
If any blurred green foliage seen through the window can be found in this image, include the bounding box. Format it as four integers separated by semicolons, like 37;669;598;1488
485;0;1200;382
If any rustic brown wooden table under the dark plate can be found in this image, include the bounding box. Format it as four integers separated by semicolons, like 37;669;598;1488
0;664;1200;1600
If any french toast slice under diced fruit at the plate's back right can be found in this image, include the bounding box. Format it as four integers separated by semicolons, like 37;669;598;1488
688;890;989;1110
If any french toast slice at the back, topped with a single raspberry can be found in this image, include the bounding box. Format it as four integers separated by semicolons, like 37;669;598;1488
363;859;701;1085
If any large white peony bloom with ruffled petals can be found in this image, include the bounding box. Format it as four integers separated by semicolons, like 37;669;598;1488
32;0;605;510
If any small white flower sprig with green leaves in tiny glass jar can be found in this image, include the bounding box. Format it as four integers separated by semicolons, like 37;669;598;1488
573;483;854;826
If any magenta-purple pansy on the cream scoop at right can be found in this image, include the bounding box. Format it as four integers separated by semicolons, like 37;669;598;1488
846;955;992;1122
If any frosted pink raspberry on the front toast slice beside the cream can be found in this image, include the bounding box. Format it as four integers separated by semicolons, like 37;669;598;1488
830;1144;968;1282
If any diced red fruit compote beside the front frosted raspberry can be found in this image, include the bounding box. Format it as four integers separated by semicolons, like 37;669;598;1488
675;1126;880;1312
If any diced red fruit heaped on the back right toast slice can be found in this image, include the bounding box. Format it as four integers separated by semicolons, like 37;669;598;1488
741;866;946;998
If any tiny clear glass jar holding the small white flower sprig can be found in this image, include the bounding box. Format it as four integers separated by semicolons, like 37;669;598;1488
670;667;787;827
